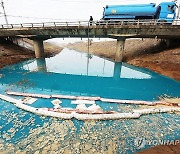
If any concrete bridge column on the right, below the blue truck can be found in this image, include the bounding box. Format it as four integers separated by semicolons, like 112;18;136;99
115;38;126;62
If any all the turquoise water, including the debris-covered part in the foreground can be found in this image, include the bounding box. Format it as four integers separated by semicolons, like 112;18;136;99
0;49;180;153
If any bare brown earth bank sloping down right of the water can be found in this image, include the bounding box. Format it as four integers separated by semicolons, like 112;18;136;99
67;39;180;81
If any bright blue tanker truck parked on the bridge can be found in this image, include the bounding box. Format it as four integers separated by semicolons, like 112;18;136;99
101;2;176;23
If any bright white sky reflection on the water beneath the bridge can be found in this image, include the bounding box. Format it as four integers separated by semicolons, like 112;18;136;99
22;49;151;79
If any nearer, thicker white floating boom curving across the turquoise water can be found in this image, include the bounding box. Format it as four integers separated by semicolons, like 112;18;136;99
0;94;180;120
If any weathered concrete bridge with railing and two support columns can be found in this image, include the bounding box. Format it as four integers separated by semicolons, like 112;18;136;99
0;20;180;62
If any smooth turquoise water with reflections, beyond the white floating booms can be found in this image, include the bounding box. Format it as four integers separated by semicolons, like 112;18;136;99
0;49;179;100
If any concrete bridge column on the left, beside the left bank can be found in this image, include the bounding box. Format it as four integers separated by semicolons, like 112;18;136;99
33;39;44;58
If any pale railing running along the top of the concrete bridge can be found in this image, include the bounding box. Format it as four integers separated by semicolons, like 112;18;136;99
0;20;180;29
